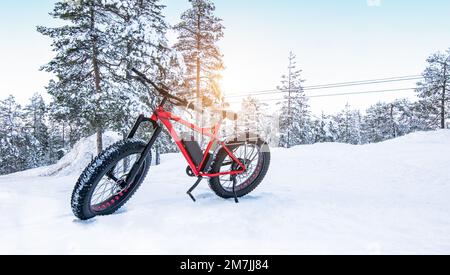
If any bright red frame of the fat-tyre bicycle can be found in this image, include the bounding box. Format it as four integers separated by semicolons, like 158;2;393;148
150;104;246;178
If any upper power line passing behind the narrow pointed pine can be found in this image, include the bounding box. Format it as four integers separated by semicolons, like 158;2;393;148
225;76;423;98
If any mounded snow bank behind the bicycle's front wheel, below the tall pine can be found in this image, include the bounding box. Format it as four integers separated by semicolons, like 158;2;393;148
40;132;121;176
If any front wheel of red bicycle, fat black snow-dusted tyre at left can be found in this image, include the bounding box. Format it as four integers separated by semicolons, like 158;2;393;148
72;139;151;220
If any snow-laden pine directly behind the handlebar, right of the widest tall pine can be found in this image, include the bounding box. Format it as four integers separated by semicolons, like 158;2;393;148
103;0;181;139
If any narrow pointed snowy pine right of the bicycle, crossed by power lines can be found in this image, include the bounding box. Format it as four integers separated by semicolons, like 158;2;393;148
278;52;312;148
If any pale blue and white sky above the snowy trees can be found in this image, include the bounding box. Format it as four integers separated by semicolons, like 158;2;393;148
0;0;450;113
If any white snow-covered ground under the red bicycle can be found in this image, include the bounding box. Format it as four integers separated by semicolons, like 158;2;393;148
0;131;450;254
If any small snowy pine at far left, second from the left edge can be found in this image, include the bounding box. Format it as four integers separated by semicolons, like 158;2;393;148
24;93;50;168
